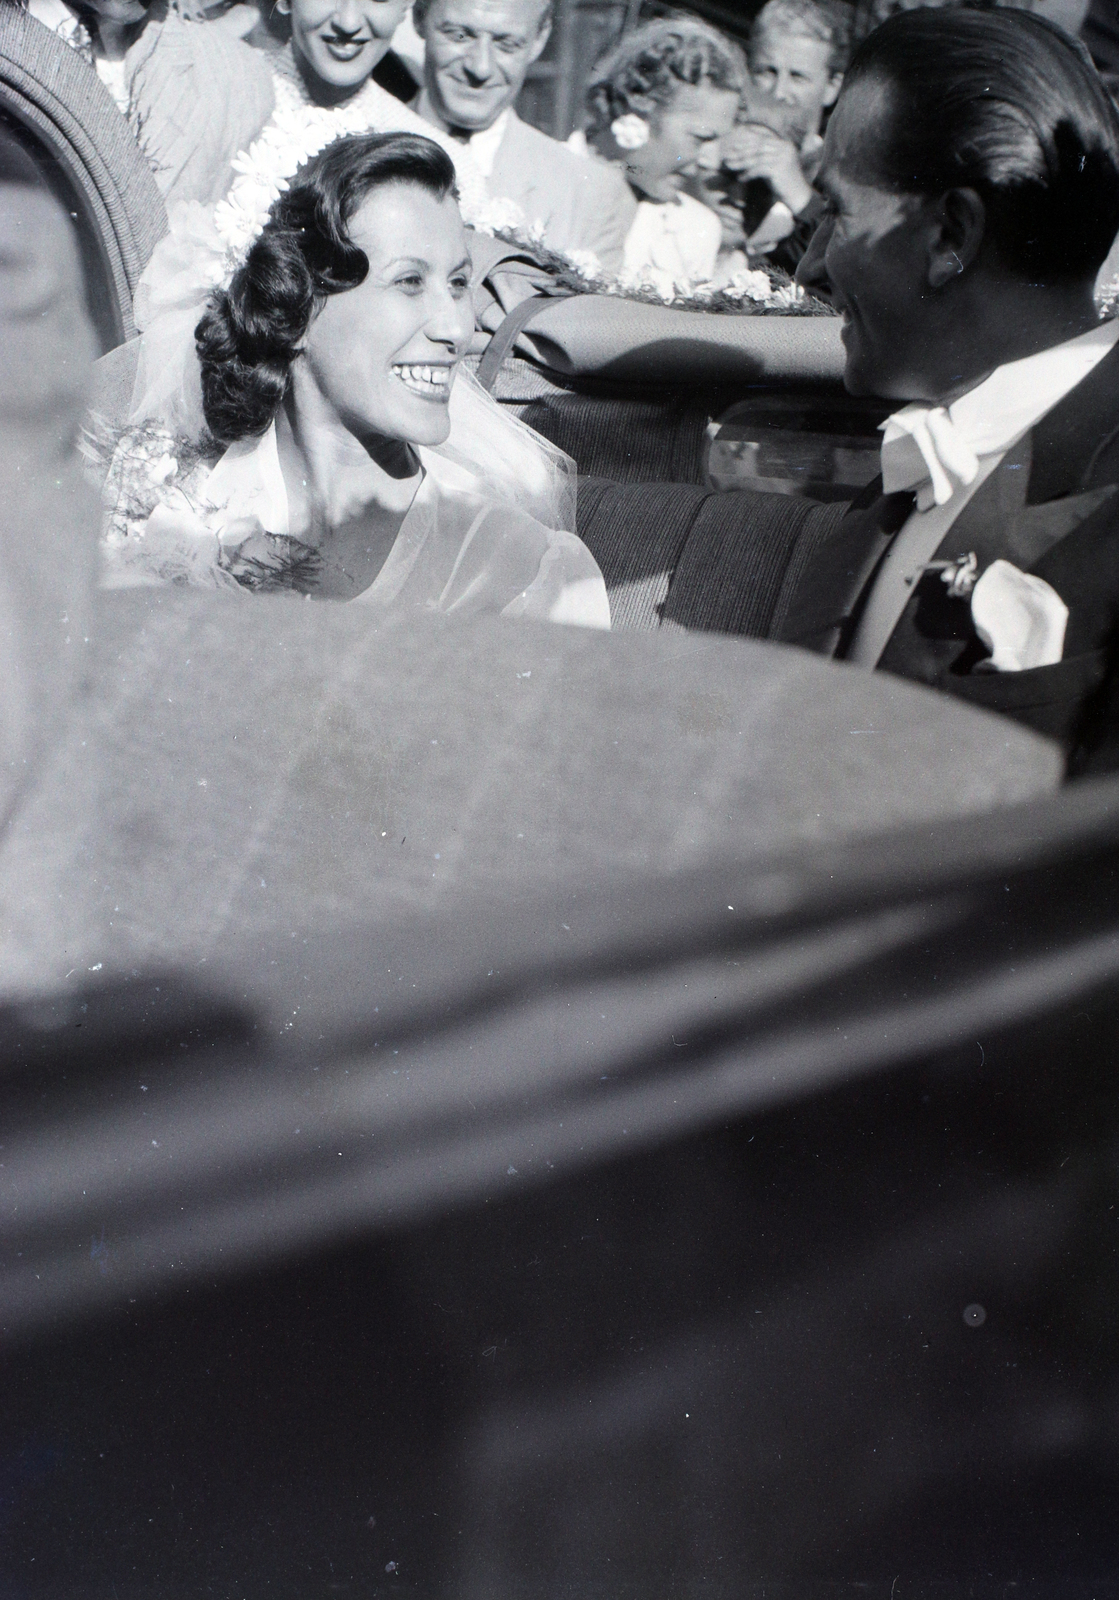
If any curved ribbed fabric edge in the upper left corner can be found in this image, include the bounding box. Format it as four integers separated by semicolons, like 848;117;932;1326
0;0;166;350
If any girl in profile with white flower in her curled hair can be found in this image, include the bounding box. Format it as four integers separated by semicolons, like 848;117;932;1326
586;18;746;298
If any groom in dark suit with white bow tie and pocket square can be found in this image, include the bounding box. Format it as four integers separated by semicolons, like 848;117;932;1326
784;10;1119;771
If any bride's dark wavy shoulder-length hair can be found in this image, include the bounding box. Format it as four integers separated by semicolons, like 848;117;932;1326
194;133;458;445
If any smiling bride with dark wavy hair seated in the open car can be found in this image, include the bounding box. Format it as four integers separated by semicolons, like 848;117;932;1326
102;134;610;627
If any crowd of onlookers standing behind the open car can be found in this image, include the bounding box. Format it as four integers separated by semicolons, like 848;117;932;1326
17;0;850;294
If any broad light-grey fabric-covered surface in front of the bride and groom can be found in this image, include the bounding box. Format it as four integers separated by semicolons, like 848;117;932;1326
0;589;1060;1003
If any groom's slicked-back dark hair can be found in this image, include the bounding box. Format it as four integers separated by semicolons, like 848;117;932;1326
844;6;1119;283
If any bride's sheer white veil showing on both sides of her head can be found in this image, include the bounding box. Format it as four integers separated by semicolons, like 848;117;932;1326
130;176;575;531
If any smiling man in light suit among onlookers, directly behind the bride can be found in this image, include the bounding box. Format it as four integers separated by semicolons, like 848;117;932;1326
413;0;636;272
